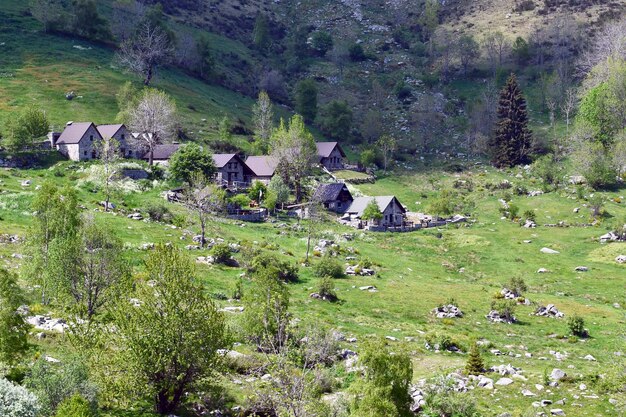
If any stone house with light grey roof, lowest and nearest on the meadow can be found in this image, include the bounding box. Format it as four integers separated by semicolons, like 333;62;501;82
344;196;407;229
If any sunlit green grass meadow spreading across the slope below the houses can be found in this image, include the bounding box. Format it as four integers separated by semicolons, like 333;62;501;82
0;158;626;416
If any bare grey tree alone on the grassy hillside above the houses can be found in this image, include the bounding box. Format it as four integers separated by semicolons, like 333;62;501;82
117;22;173;85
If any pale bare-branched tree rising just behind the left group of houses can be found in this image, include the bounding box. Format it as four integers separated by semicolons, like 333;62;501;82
130;89;176;165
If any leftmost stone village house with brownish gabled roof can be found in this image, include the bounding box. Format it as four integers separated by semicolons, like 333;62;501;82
51;122;102;161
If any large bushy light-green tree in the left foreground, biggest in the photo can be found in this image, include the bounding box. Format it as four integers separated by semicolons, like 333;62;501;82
106;246;229;414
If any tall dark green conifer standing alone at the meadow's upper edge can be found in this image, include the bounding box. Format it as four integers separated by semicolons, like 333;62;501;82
490;74;532;167
